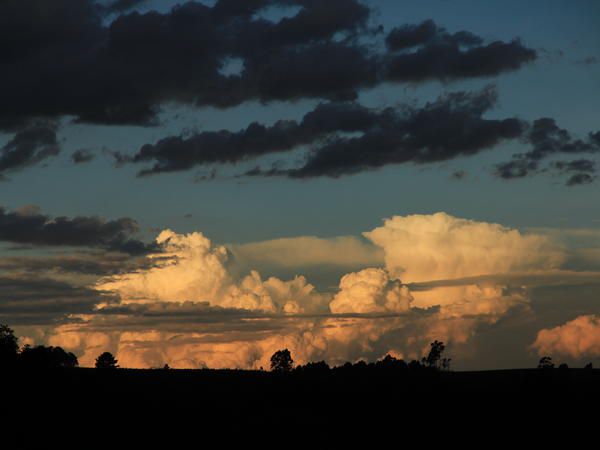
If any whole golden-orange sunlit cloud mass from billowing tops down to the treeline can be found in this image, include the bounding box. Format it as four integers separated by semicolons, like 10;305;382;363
43;213;563;368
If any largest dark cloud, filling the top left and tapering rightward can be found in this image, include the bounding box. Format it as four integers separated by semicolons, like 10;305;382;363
0;0;535;130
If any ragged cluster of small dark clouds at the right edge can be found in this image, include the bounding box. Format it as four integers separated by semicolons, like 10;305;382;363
496;117;600;186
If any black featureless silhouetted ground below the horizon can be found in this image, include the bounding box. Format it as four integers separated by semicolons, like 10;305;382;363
1;369;600;442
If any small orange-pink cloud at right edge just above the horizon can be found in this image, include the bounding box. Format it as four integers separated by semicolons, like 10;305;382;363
532;315;600;359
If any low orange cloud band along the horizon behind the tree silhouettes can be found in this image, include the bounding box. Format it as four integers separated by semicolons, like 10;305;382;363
49;315;474;369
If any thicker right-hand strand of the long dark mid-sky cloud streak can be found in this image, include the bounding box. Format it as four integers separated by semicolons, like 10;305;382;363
248;87;524;178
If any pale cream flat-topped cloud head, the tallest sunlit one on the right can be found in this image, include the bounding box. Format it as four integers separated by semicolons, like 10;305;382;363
363;213;564;283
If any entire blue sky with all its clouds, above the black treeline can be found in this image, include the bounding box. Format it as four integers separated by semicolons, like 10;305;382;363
0;0;600;369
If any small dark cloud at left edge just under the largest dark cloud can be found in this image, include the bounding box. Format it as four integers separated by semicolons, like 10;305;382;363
0;123;60;178
